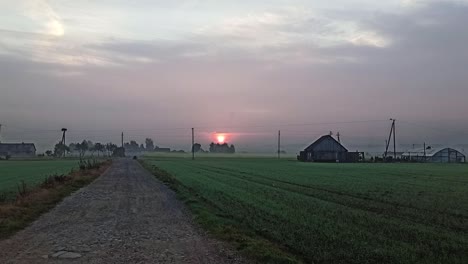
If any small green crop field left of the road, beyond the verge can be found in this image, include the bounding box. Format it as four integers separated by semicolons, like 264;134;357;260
0;159;78;195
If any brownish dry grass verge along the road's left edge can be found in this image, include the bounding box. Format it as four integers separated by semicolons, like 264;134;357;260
0;161;111;240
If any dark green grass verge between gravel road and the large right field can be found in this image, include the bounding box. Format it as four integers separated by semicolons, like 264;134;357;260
140;160;303;263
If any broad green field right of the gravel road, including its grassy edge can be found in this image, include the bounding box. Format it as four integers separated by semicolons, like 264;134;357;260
145;156;468;263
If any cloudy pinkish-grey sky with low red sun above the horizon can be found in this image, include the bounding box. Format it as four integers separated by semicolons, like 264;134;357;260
0;0;468;152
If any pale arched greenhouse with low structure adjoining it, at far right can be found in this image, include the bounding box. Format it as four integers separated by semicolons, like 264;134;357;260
402;147;466;163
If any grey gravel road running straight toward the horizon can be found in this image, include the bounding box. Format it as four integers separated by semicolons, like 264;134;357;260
0;159;244;263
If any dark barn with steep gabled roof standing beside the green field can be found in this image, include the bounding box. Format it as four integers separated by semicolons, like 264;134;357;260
297;135;363;162
